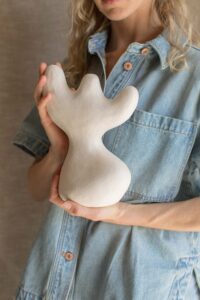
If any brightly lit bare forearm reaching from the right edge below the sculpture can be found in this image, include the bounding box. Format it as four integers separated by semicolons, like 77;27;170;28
121;197;200;231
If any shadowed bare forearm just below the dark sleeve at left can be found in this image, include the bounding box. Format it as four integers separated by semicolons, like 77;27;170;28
28;148;61;201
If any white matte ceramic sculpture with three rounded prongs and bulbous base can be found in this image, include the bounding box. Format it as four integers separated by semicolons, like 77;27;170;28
43;65;139;207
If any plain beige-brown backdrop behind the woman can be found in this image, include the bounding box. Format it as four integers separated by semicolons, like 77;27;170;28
0;0;200;300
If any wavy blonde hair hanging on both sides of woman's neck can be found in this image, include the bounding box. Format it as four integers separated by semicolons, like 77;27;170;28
62;0;200;88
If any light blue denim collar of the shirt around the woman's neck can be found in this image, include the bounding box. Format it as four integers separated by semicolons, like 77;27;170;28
88;29;170;69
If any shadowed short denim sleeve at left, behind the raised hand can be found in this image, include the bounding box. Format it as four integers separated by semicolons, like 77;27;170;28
12;104;50;158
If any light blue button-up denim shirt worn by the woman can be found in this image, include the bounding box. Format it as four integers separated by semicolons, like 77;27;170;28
13;30;200;300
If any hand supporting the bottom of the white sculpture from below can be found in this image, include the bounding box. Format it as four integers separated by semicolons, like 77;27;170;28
49;173;129;224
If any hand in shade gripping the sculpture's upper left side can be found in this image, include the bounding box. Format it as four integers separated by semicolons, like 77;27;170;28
34;63;69;164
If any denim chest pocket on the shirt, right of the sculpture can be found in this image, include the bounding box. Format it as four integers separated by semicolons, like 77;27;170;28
103;110;197;203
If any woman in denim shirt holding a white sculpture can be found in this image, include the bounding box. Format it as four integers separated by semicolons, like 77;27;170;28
13;0;200;300
